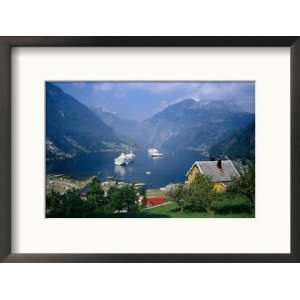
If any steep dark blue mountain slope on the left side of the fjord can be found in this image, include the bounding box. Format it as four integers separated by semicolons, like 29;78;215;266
46;83;121;160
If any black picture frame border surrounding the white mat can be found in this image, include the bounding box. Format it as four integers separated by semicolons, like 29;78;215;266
0;36;300;263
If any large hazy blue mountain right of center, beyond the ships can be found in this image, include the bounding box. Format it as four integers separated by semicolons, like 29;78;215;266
143;99;254;155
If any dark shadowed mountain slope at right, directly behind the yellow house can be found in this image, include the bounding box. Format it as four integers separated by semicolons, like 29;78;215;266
210;121;255;160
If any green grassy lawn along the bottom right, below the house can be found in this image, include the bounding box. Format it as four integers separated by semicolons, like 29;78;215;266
142;202;254;218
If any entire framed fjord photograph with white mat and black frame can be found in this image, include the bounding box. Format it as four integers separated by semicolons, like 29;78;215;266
0;37;300;262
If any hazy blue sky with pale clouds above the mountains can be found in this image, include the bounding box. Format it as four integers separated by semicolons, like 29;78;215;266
53;81;255;121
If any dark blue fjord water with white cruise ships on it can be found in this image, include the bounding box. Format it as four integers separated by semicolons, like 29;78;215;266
47;149;207;188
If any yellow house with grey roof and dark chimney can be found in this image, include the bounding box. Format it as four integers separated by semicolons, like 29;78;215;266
186;160;240;193
